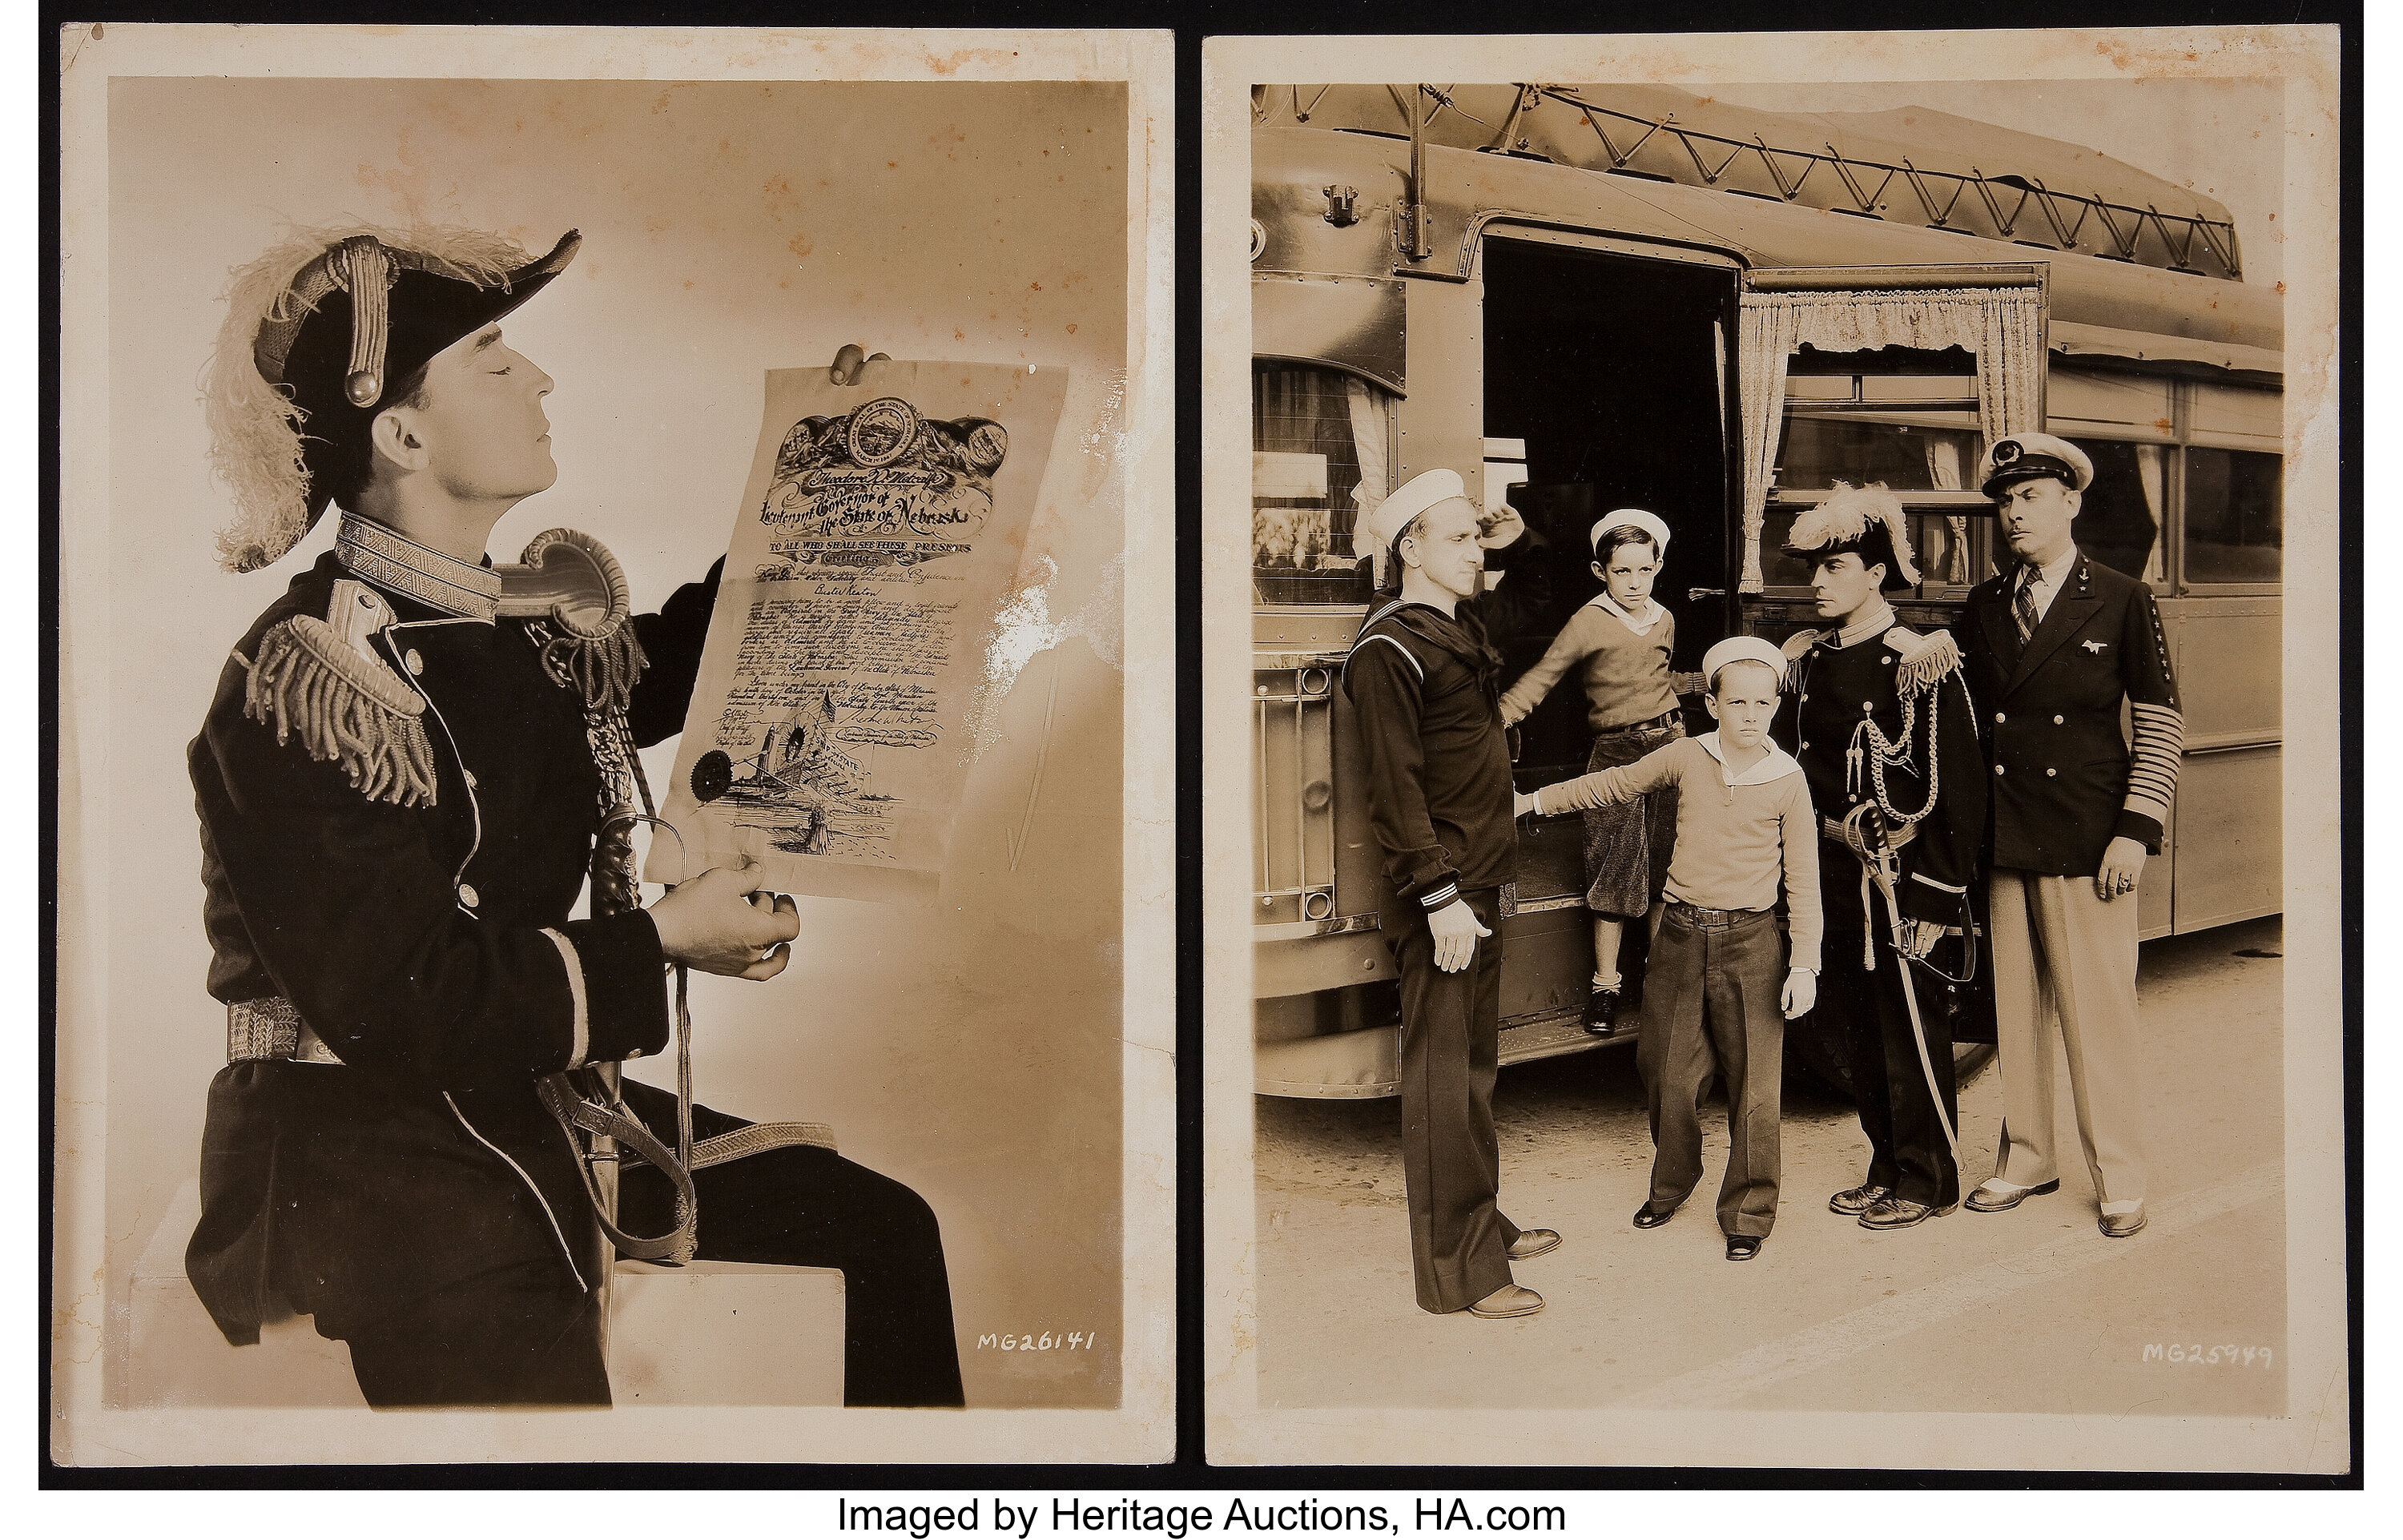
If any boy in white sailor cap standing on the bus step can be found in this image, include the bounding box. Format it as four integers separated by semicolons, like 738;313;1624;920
1502;507;1685;1038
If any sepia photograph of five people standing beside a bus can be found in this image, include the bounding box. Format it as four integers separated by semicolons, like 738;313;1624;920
1202;29;2353;1473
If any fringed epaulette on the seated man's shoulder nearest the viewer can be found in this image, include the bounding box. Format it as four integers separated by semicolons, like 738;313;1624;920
233;579;435;807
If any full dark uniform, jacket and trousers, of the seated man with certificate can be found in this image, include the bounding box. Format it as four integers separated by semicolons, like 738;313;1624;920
187;519;959;1405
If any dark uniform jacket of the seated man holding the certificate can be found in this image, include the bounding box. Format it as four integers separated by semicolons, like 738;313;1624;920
187;555;718;1343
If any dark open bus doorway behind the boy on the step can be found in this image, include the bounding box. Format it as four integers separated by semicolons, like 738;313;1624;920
1399;219;1740;1062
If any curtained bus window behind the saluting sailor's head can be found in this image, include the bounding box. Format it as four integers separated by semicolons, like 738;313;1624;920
1252;360;1394;605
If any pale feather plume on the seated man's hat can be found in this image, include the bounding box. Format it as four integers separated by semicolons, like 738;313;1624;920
199;223;545;572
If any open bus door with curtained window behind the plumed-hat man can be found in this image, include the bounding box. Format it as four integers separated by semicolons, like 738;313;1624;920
1737;262;2050;1081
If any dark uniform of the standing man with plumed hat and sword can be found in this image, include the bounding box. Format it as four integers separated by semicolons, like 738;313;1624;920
1773;610;1985;1208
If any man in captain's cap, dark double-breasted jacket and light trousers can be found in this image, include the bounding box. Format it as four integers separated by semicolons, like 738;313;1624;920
1963;432;2184;1237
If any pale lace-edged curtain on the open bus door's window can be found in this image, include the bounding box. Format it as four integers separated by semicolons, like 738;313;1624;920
1737;288;2045;593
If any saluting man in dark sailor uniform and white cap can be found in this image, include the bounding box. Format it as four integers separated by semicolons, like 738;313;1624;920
1343;471;1560;1317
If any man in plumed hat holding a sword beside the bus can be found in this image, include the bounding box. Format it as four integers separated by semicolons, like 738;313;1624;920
1776;485;1985;1230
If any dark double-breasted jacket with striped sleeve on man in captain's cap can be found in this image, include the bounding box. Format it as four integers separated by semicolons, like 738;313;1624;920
1961;550;2184;877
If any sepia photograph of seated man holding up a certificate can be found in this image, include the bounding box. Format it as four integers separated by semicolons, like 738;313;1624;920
48;24;1175;1466
